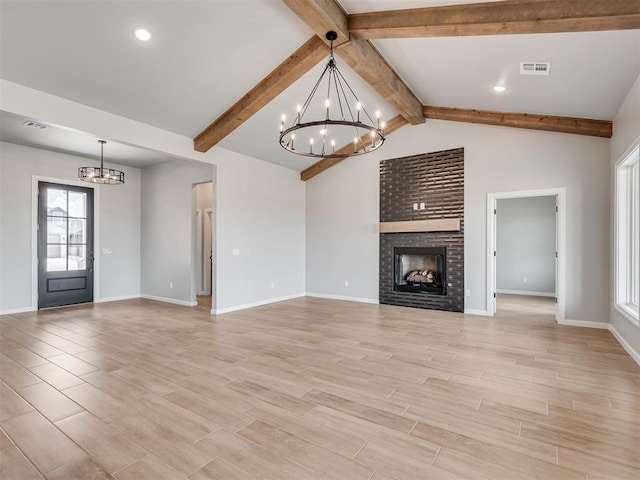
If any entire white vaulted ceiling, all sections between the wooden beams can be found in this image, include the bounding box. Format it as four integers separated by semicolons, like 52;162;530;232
0;0;640;170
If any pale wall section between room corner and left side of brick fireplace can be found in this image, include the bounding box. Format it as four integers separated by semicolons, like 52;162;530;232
306;154;386;301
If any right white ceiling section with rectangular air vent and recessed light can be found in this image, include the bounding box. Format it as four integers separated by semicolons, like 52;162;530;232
374;30;640;120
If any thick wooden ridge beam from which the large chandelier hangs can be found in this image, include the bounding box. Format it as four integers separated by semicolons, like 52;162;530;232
282;0;424;125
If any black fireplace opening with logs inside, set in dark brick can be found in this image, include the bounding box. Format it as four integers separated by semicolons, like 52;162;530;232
393;247;447;295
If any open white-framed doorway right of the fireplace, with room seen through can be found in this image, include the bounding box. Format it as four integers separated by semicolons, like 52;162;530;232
487;188;566;322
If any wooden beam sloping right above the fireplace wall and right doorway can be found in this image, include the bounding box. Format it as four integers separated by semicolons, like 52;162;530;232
424;105;613;138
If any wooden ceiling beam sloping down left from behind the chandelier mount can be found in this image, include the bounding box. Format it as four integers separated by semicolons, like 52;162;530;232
193;35;329;152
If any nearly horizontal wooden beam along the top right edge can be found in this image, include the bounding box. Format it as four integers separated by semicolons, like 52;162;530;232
348;0;640;39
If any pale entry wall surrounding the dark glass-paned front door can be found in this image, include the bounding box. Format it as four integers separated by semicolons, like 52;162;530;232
0;143;140;313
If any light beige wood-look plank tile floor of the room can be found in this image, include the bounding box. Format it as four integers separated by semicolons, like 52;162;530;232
0;298;640;480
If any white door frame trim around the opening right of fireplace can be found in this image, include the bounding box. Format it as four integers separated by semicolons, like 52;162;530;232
486;187;567;323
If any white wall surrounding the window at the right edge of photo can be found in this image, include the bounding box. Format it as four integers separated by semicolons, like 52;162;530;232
609;76;640;363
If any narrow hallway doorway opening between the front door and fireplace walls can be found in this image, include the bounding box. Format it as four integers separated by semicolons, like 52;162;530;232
193;182;213;306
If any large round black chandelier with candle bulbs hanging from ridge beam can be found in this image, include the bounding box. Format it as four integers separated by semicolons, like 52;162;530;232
280;31;385;158
